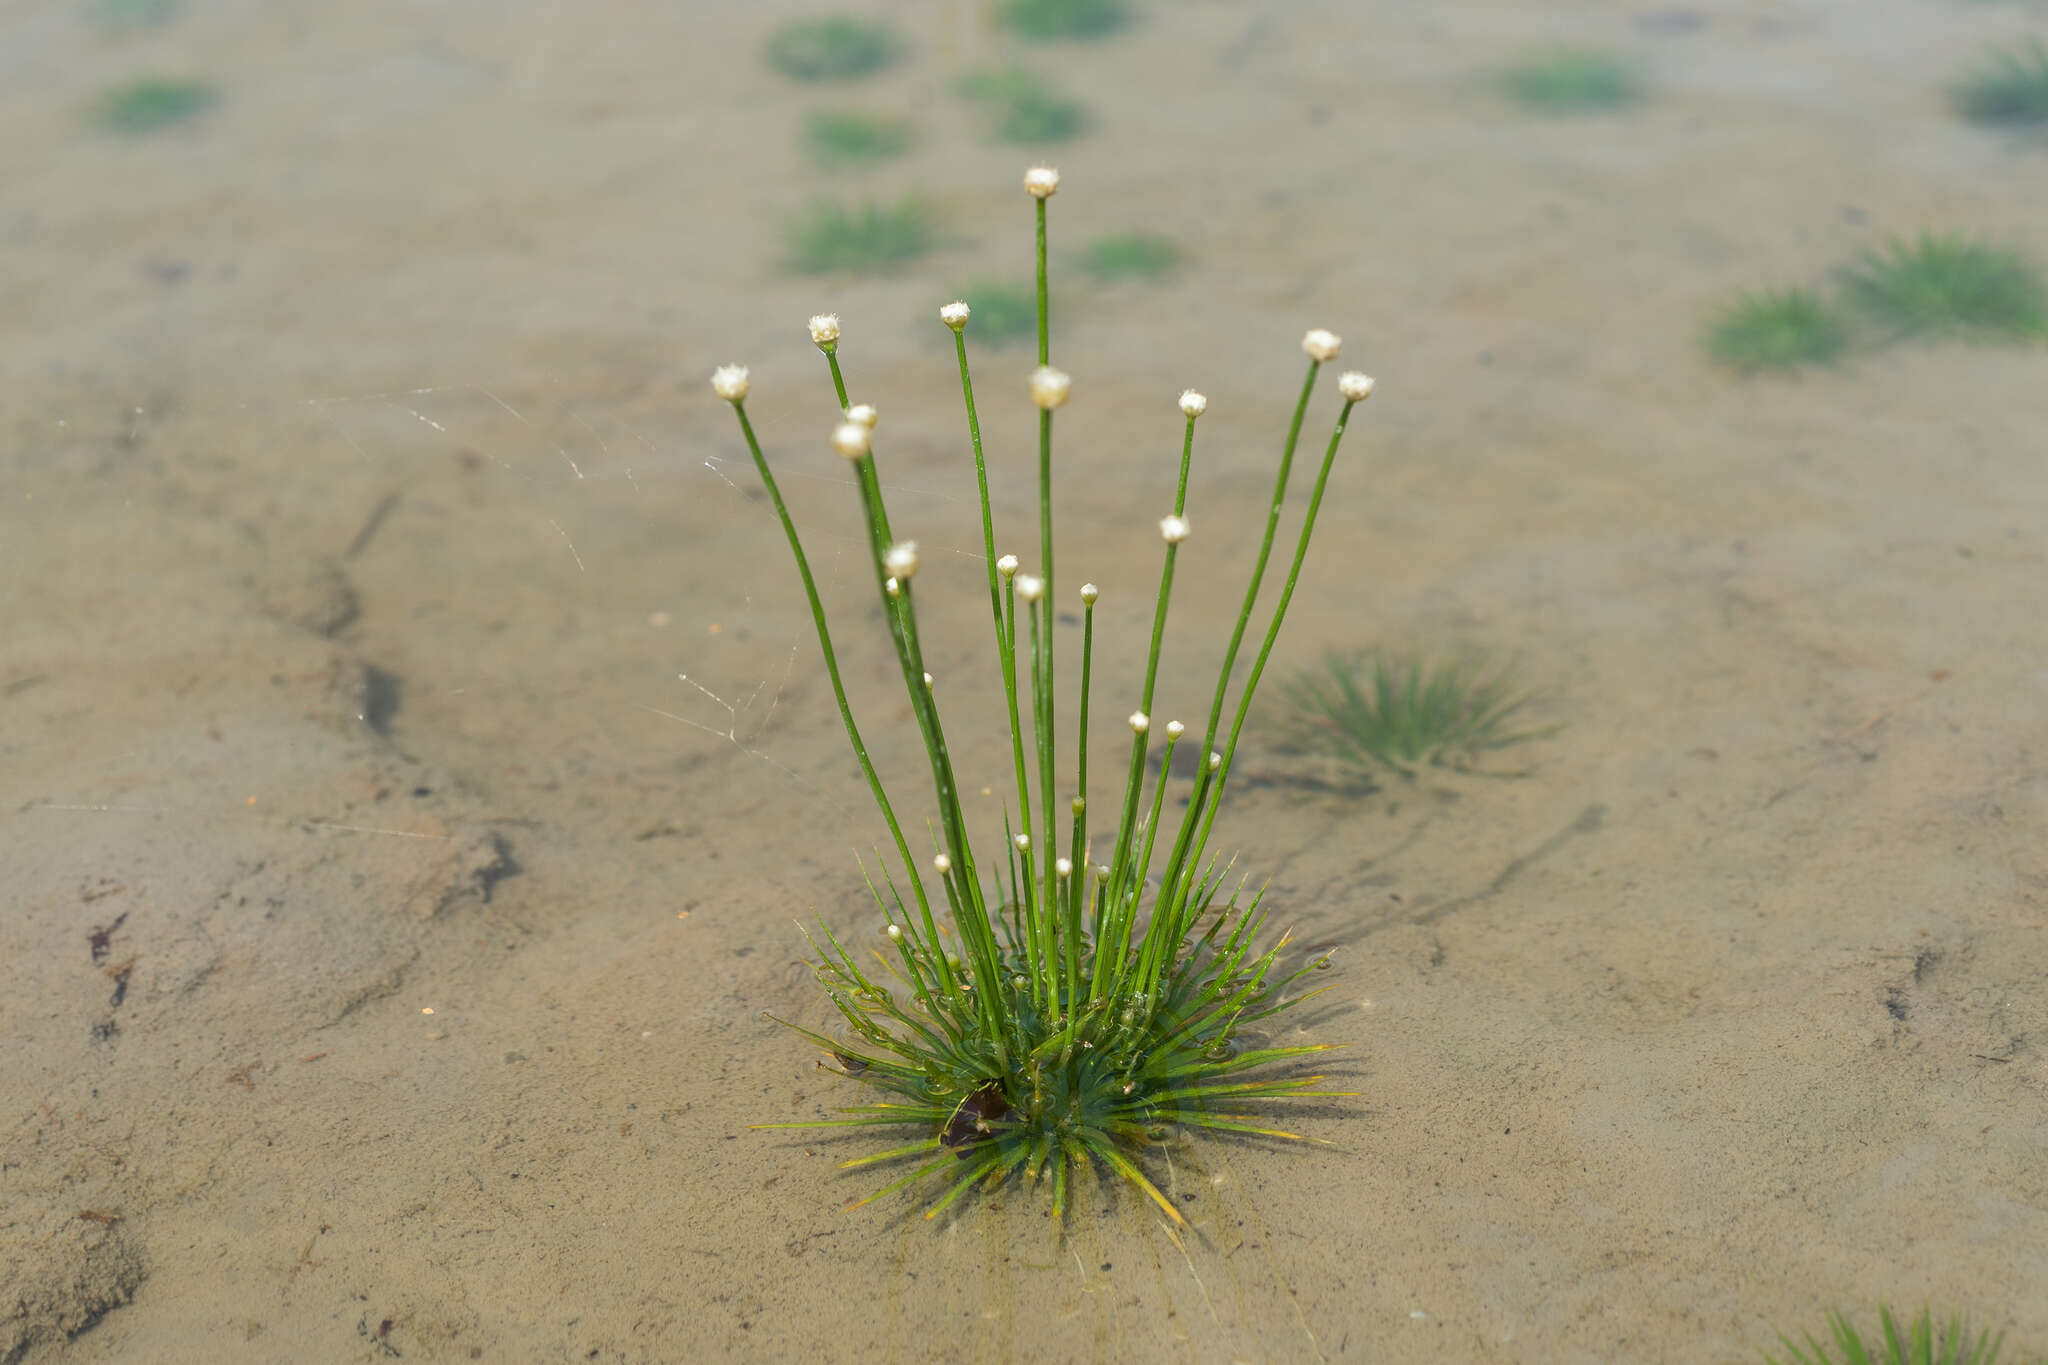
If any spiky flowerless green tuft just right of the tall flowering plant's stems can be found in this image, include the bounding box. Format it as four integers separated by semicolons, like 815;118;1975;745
1280;655;1556;782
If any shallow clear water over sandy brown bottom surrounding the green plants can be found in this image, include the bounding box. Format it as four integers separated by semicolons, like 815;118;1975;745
0;0;2048;1361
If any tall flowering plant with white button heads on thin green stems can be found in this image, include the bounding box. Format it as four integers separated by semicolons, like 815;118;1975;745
711;166;1372;1226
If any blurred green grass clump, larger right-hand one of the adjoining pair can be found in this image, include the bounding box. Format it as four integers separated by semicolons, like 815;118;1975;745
1841;233;2048;342
